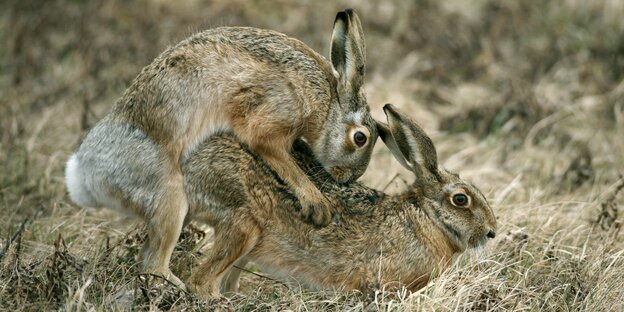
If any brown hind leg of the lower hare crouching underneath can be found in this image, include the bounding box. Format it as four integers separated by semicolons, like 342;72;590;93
188;219;260;298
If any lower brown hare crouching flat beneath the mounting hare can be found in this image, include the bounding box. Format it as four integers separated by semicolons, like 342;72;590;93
182;104;496;297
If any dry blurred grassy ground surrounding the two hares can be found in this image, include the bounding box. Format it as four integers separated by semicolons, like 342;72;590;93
0;0;624;311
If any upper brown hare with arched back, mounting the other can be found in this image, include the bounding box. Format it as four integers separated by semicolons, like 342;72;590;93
66;10;377;285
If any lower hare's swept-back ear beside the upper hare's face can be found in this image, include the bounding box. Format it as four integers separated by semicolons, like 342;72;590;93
380;104;438;177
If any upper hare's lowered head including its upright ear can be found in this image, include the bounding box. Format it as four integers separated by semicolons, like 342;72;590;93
314;9;377;183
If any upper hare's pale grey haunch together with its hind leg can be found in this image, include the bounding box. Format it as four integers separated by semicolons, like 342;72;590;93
77;119;188;286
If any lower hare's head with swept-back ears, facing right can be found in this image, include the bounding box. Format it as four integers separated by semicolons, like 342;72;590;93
377;104;496;251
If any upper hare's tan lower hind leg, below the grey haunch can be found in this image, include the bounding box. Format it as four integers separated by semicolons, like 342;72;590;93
140;175;188;288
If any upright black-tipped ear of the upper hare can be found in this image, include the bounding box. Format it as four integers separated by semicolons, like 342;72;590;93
330;9;366;92
